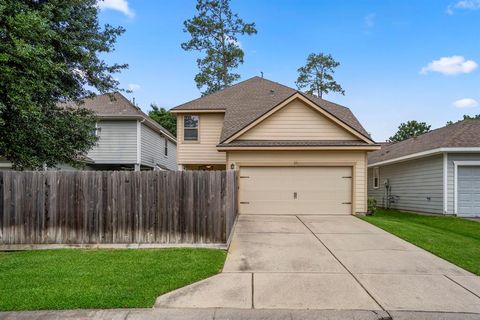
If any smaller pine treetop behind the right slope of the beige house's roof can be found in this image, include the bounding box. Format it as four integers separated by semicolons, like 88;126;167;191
295;53;345;98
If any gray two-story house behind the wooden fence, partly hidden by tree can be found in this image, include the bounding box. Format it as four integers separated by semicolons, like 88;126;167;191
0;92;177;170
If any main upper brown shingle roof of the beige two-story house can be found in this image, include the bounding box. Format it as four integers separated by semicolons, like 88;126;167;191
172;77;371;143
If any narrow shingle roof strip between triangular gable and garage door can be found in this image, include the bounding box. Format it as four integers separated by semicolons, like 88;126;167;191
217;140;371;147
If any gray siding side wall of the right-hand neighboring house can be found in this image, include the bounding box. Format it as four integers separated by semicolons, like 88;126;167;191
368;155;443;213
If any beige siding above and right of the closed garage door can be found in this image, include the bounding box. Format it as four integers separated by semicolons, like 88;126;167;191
227;150;367;212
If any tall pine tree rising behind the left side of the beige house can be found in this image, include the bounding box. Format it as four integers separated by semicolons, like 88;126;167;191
181;0;257;95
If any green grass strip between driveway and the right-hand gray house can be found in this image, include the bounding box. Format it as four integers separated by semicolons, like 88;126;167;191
361;210;480;275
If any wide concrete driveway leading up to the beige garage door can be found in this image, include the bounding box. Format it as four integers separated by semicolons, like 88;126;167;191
156;215;480;314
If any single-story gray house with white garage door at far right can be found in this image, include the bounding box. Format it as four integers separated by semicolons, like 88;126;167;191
368;120;480;217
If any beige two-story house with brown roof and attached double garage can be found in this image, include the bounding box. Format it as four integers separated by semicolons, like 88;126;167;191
172;77;380;214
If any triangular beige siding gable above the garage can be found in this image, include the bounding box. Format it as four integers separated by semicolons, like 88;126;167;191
238;99;358;140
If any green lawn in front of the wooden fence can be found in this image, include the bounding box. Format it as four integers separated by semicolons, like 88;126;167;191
0;249;226;311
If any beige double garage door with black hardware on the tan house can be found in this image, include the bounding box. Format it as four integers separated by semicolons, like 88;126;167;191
239;167;352;215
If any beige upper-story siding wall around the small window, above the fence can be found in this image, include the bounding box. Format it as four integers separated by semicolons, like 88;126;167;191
177;113;226;164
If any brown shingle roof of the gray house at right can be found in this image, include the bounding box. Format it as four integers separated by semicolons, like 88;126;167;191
368;120;480;165
